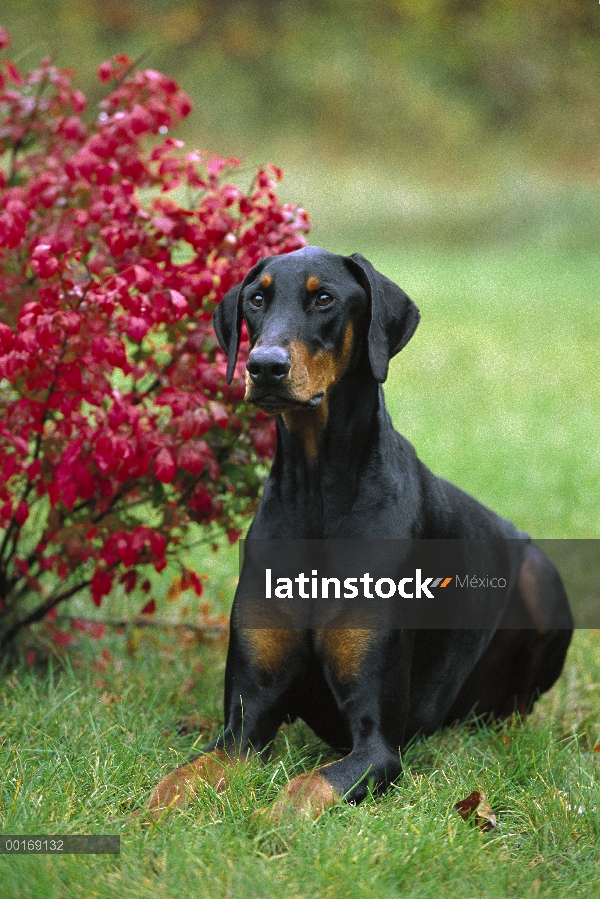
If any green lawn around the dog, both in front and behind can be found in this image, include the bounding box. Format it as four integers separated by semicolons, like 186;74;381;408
0;243;600;899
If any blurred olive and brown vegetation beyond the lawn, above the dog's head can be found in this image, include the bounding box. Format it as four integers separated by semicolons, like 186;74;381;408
0;0;600;249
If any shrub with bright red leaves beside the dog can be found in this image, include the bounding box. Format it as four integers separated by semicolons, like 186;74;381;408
0;29;308;644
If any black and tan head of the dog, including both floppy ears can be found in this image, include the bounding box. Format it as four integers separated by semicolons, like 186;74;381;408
213;247;419;412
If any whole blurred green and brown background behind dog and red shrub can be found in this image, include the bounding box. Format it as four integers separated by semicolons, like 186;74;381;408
0;0;600;540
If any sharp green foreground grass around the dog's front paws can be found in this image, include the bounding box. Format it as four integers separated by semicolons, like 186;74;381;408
0;633;600;899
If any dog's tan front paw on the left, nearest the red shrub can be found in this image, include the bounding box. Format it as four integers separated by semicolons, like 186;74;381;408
146;749;230;818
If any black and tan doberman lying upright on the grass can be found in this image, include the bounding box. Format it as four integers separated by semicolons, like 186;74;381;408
148;247;572;815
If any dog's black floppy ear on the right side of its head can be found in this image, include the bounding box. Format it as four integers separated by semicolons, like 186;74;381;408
349;253;421;383
